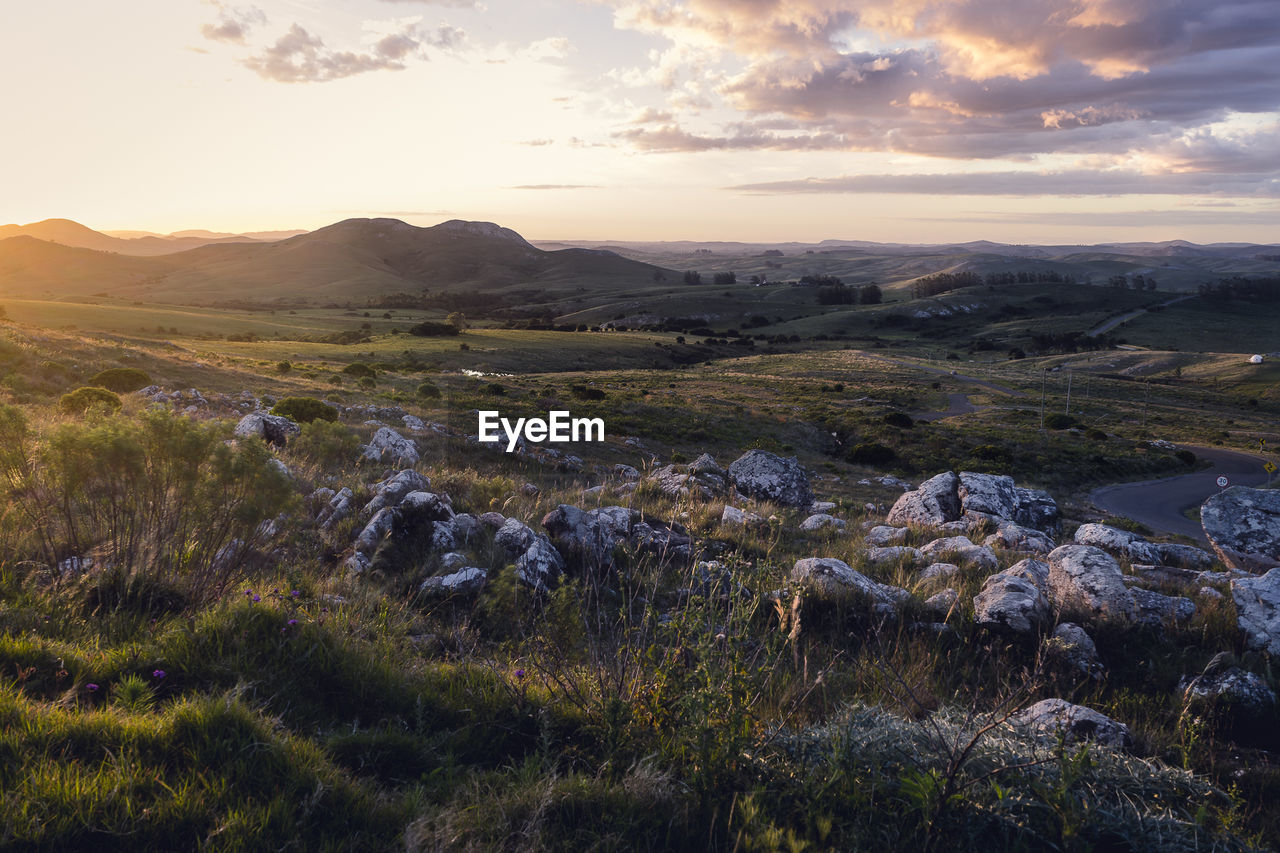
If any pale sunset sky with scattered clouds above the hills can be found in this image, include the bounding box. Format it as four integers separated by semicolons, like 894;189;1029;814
0;0;1280;243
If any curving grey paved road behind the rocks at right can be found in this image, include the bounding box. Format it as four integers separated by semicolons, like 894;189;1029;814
1089;444;1267;542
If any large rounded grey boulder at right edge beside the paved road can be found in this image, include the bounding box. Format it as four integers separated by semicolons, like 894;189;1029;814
1201;485;1280;573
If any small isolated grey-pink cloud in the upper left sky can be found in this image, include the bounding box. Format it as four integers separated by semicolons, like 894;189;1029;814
243;18;466;83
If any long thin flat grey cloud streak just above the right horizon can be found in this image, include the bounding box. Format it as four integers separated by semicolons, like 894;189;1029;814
726;169;1280;199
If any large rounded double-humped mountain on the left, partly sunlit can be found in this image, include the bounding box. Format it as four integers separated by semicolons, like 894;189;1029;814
0;219;669;305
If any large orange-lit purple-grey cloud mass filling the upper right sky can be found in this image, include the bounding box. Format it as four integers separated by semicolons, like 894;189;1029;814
611;0;1280;159
